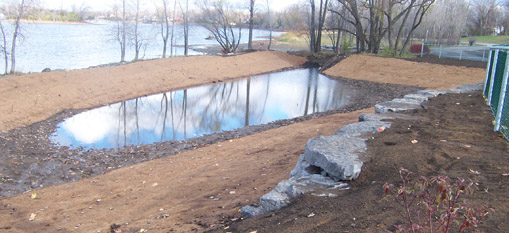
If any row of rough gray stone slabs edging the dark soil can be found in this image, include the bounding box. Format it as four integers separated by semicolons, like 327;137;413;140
241;83;483;218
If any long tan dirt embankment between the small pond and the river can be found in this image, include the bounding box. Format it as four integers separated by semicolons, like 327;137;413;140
0;52;306;130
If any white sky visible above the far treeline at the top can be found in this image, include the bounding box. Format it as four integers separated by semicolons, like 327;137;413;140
41;0;302;11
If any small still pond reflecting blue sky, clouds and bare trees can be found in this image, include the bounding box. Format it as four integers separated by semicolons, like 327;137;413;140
51;68;350;149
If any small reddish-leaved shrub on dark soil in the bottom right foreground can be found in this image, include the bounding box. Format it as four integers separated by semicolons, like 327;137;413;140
384;168;488;233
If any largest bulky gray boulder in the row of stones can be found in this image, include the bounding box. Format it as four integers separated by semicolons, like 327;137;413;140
304;135;367;181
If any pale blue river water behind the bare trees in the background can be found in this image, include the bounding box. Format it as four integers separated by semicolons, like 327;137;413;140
0;21;281;73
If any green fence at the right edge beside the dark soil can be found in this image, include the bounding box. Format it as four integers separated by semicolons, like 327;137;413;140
483;45;509;141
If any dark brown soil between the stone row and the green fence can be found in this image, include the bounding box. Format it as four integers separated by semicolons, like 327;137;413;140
217;92;509;232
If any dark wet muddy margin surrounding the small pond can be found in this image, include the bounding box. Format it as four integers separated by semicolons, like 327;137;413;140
0;75;419;196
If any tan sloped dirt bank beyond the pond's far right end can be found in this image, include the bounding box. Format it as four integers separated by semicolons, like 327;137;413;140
324;55;486;89
